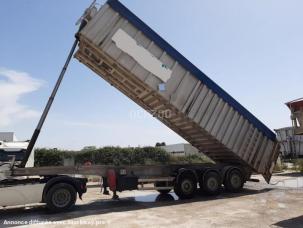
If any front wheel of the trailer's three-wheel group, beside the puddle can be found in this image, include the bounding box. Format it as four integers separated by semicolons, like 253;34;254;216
174;173;197;199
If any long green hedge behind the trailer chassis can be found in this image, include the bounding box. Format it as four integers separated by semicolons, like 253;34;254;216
35;147;211;166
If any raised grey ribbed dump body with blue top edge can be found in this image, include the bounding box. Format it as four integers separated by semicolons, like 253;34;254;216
75;0;279;181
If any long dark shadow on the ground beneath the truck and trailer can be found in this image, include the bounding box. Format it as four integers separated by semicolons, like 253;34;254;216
0;188;273;226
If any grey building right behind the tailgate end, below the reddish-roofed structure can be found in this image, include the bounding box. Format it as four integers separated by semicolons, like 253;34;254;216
275;127;303;158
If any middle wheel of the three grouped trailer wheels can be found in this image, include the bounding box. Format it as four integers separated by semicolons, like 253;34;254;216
199;171;221;196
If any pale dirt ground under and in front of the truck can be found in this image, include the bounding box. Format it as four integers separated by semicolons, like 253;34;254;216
0;173;303;228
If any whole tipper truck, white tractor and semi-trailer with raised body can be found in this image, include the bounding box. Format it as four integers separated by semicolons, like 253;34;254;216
0;0;279;211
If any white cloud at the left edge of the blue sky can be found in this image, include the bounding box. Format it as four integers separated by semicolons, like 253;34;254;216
0;68;43;127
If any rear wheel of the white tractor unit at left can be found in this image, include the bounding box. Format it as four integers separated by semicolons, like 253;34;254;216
46;183;77;212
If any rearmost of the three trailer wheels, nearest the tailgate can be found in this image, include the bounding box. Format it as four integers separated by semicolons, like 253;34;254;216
224;169;244;192
